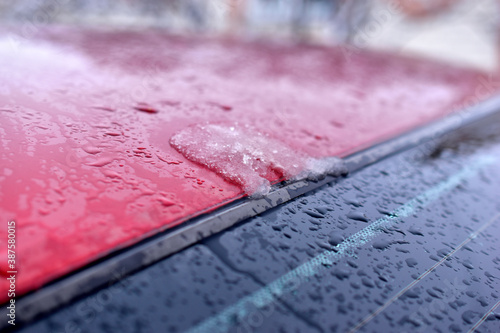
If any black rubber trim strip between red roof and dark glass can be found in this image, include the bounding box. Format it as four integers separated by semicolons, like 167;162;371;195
6;96;500;329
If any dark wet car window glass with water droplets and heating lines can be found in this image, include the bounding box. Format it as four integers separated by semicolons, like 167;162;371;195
18;116;500;332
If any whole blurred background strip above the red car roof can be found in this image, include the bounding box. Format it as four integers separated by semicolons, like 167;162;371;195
0;0;500;71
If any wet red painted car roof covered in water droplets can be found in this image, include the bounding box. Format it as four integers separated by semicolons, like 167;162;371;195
0;28;488;301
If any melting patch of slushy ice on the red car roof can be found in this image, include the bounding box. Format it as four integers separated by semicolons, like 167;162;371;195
170;123;345;196
